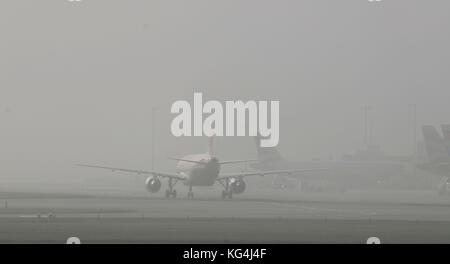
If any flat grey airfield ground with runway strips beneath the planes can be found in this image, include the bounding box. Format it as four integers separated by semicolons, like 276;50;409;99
0;190;450;243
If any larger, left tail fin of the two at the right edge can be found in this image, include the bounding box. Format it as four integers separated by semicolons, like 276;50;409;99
422;126;450;163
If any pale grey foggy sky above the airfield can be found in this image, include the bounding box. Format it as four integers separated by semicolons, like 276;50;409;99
0;0;450;190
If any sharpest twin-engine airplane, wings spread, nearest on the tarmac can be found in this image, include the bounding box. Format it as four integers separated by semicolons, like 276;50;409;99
78;137;316;199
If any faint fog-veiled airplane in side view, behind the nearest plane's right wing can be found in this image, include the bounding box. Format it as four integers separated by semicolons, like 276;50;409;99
250;136;405;191
